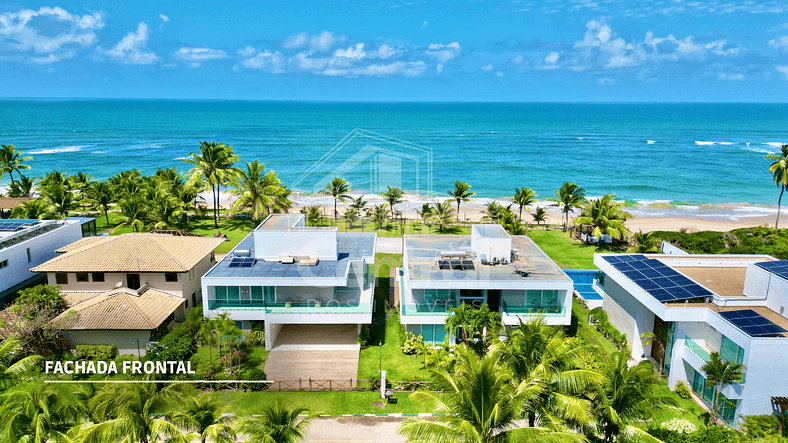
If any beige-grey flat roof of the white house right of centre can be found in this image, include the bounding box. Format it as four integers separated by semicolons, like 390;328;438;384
405;235;571;282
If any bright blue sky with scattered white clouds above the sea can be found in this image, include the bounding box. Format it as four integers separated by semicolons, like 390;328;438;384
0;0;788;102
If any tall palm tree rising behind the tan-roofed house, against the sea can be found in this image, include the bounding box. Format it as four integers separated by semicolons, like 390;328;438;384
184;141;239;228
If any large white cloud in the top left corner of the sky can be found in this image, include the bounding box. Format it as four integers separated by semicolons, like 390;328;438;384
0;7;104;64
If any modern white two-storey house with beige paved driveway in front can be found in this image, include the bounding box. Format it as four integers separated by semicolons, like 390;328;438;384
202;214;377;354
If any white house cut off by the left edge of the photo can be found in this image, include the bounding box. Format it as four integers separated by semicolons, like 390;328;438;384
0;219;82;306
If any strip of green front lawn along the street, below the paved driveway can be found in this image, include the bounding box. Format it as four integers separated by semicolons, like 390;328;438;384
216;391;429;415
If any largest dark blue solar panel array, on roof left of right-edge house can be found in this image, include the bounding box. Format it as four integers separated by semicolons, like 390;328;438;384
604;254;712;303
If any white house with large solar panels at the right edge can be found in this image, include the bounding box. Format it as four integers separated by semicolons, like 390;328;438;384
594;254;788;426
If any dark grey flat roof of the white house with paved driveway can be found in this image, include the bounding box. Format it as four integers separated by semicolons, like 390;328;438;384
204;232;375;278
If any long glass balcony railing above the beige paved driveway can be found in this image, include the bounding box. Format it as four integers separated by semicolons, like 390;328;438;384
208;299;372;314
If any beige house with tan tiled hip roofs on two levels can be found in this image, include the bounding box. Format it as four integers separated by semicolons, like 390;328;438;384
32;233;224;354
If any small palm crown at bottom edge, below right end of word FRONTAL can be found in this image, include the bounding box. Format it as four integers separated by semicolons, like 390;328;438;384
172;394;236;443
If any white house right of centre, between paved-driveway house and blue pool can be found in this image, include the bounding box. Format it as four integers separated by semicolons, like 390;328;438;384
398;224;573;343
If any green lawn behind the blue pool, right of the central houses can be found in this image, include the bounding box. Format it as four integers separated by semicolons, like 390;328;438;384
528;229;615;269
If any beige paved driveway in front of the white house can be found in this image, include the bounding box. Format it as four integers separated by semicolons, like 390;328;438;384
264;325;361;381
